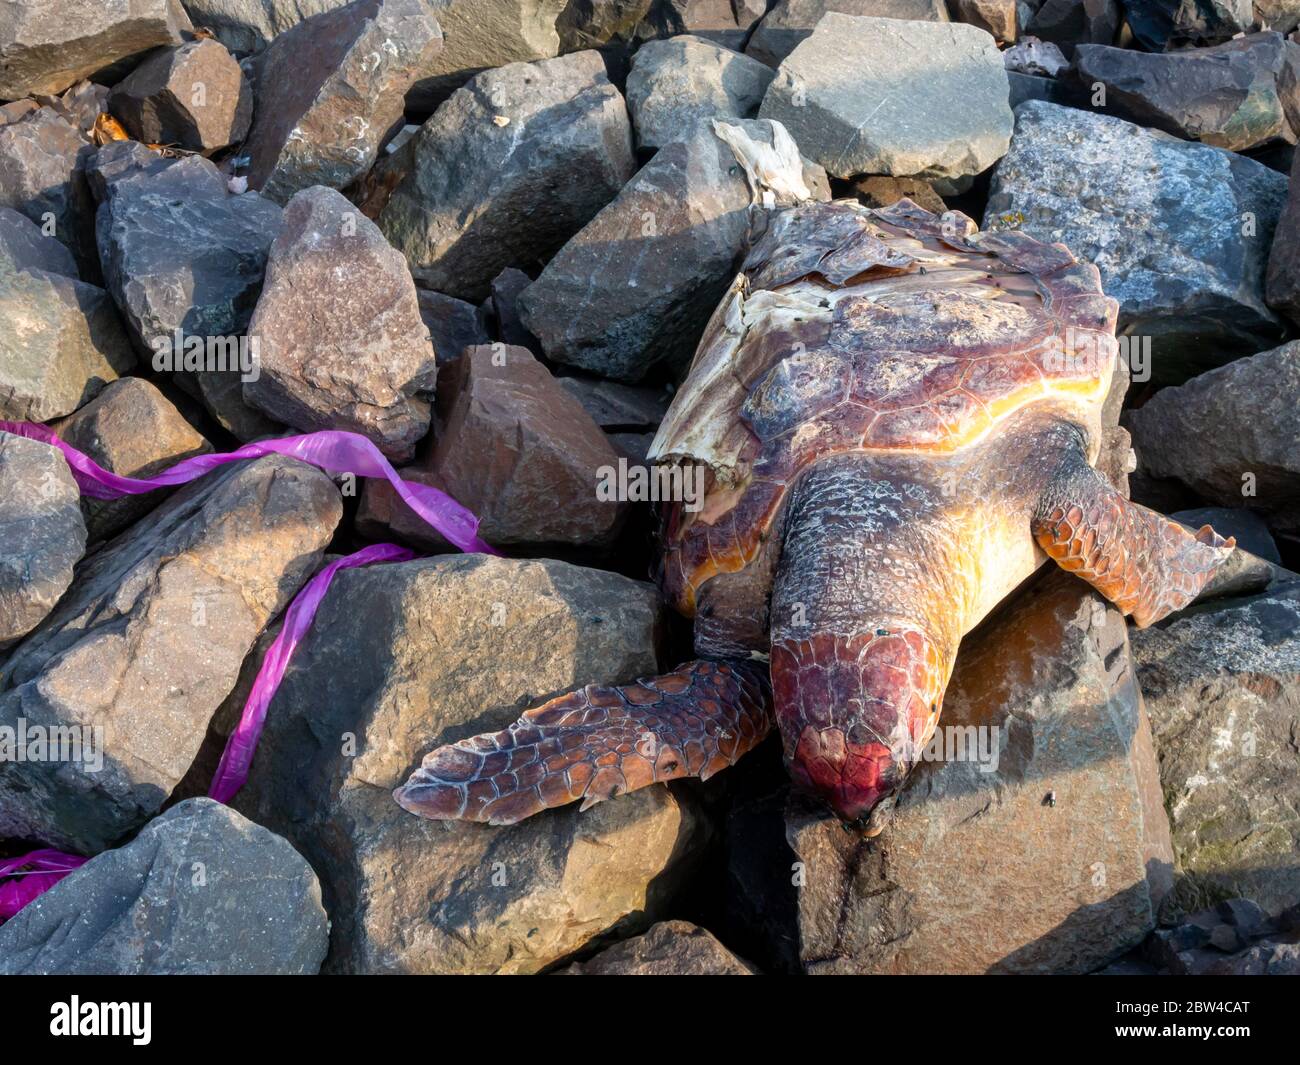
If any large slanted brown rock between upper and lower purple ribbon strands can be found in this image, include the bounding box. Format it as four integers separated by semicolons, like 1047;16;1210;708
0;456;342;853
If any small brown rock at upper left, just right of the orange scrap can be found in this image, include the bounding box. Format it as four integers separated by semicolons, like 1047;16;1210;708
108;38;252;152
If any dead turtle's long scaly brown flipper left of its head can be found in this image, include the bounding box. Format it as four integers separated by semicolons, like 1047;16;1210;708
393;661;772;824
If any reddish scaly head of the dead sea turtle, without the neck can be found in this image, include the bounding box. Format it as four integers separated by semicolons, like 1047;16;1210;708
772;625;946;824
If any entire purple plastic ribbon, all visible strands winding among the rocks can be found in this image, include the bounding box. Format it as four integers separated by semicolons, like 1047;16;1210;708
0;421;501;921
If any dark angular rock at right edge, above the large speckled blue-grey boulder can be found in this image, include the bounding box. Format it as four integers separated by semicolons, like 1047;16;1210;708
1075;33;1295;151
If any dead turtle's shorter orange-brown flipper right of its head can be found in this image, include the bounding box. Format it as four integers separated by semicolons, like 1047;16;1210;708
1034;446;1236;628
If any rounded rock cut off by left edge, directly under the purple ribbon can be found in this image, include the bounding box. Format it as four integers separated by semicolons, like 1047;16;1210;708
0;433;86;648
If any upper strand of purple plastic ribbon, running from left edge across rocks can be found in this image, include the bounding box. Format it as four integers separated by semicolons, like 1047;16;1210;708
0;421;501;555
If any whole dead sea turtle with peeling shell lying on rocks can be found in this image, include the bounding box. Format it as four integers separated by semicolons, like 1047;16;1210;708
395;200;1234;824
